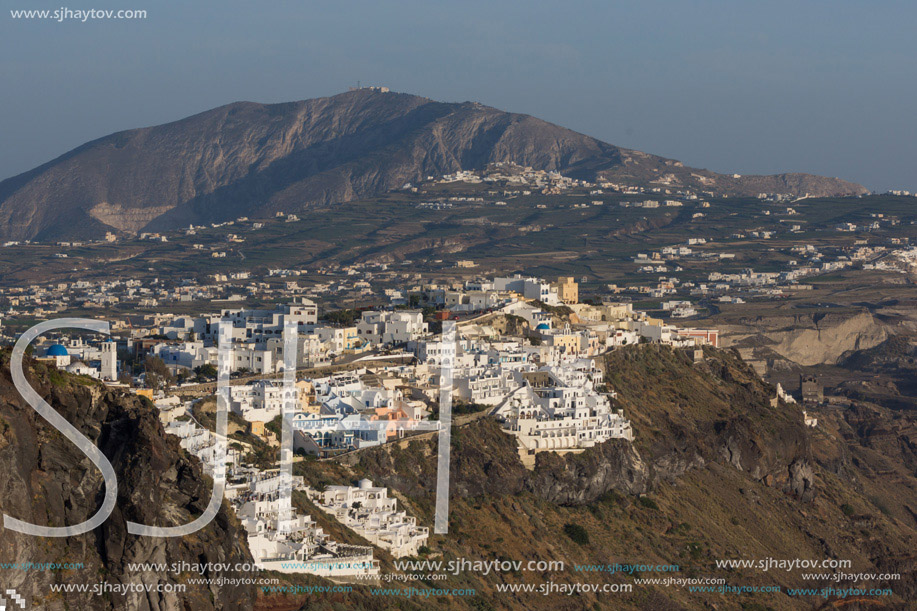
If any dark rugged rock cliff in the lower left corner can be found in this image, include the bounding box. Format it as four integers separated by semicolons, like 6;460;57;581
0;353;254;611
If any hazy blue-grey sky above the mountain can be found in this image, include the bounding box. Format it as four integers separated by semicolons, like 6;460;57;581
0;0;917;191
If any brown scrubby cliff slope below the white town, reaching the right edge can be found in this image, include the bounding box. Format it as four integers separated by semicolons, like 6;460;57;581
298;345;917;611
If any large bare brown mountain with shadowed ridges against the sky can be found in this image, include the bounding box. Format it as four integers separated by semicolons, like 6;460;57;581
0;89;866;239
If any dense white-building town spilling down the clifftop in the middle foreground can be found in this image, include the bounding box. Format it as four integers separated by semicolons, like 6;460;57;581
7;268;736;577
